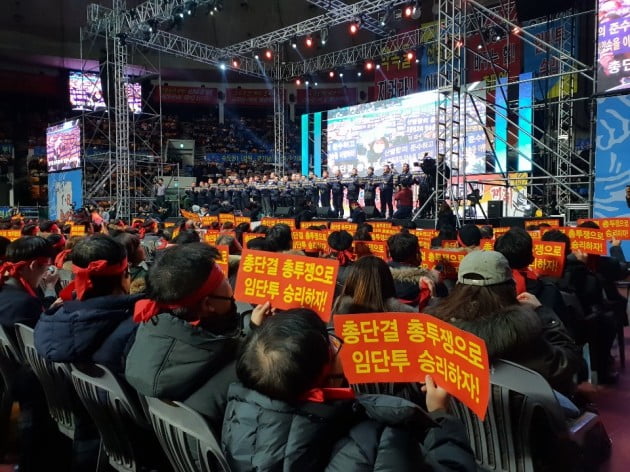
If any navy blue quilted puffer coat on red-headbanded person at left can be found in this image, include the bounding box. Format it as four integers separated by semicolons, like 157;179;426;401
35;294;142;374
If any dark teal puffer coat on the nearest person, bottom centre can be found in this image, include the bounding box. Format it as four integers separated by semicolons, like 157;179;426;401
222;384;476;472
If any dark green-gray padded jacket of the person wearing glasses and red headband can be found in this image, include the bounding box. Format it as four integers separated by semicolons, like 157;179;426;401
125;313;240;432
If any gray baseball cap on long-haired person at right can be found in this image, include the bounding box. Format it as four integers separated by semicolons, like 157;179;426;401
457;251;512;287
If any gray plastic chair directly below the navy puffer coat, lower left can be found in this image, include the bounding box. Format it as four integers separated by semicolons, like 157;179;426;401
71;363;165;472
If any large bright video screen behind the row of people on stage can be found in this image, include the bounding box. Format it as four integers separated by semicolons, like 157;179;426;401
327;91;486;175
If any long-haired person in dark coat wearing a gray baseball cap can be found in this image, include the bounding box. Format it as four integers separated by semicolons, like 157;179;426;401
425;251;581;396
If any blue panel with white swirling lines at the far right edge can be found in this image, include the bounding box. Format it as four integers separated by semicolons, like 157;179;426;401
593;96;630;257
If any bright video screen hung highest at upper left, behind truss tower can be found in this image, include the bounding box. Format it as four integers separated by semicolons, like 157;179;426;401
68;71;142;113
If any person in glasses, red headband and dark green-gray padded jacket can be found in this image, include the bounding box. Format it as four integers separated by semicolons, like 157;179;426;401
125;243;269;433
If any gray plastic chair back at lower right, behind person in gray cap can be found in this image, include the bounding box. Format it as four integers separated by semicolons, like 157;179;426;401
451;360;568;472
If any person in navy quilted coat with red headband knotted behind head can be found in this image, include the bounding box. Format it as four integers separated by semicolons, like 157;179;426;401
35;234;140;374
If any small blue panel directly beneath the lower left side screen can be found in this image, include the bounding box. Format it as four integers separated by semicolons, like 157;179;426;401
48;169;83;220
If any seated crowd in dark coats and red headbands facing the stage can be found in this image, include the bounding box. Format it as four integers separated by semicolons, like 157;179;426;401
0;209;627;471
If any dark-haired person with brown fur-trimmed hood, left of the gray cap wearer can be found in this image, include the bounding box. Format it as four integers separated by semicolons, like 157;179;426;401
387;233;438;307
